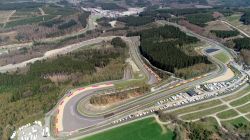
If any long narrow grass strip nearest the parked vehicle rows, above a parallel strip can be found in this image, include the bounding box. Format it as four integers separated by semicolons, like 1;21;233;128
170;100;222;115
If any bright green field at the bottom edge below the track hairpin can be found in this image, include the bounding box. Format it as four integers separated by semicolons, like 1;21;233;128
81;118;175;140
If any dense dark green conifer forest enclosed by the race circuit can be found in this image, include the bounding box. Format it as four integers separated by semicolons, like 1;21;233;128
136;26;210;73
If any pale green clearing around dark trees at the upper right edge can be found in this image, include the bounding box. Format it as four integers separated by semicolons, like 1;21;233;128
226;13;250;35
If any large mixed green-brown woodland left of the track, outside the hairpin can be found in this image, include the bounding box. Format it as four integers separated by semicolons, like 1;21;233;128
0;41;127;139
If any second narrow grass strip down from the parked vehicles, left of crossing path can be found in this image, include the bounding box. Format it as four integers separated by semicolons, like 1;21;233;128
181;105;228;120
